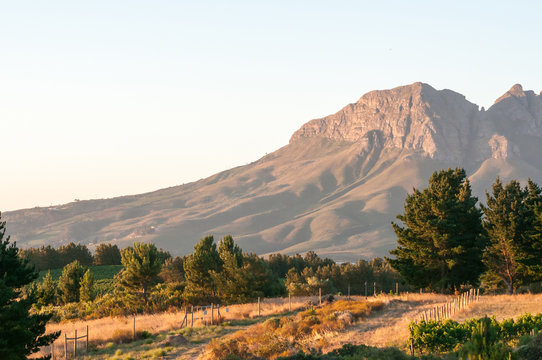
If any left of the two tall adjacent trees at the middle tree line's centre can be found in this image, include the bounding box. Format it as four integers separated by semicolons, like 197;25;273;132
184;236;222;303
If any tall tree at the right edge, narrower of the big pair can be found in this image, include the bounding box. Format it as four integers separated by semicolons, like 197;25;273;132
482;178;540;294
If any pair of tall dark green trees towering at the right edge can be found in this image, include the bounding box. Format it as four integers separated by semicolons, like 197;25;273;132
388;169;542;293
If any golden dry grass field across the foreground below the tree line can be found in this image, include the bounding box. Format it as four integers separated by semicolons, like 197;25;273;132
33;294;542;360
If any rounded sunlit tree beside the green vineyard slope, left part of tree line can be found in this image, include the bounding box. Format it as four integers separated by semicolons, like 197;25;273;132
120;243;162;306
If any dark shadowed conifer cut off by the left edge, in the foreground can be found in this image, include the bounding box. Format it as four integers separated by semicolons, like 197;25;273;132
0;212;60;360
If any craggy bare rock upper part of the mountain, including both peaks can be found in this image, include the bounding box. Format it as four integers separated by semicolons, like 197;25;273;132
290;83;542;165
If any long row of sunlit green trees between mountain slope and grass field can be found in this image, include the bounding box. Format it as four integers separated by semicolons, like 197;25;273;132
33;236;400;315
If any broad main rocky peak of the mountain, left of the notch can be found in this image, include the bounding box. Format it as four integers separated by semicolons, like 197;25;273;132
290;82;478;160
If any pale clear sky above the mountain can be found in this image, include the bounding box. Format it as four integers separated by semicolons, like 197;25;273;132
0;0;542;211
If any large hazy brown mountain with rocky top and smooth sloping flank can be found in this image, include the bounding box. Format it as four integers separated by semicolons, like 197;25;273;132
3;83;542;261
